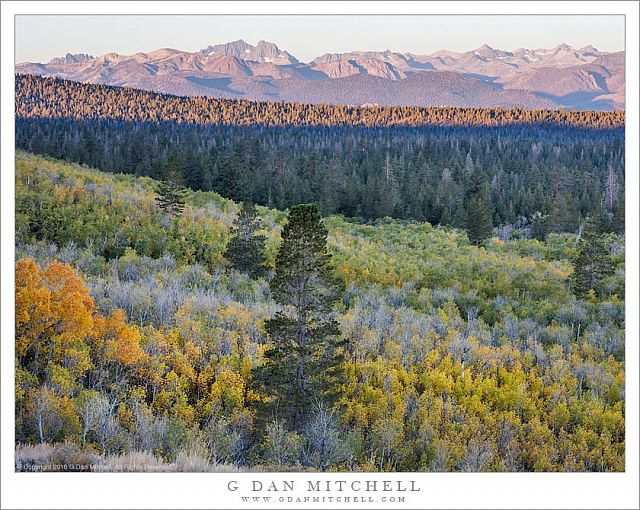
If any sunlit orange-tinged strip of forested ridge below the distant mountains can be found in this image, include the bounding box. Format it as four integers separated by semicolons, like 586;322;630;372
16;74;625;129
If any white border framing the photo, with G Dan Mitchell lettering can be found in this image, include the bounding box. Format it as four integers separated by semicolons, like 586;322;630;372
0;1;640;508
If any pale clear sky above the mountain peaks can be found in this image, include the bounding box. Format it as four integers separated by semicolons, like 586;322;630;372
16;15;624;62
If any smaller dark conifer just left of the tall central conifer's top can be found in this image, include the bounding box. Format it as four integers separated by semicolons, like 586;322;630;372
224;200;267;278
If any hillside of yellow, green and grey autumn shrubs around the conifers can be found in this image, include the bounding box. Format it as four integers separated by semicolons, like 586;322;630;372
16;152;624;471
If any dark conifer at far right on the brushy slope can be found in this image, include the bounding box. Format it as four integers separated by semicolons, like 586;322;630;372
573;217;613;297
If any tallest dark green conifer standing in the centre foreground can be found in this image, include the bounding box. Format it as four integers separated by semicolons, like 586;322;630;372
258;205;344;431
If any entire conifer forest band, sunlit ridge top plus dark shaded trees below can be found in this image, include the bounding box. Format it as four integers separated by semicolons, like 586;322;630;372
16;76;624;235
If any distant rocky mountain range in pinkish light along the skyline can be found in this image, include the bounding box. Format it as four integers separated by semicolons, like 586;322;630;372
16;40;625;110
